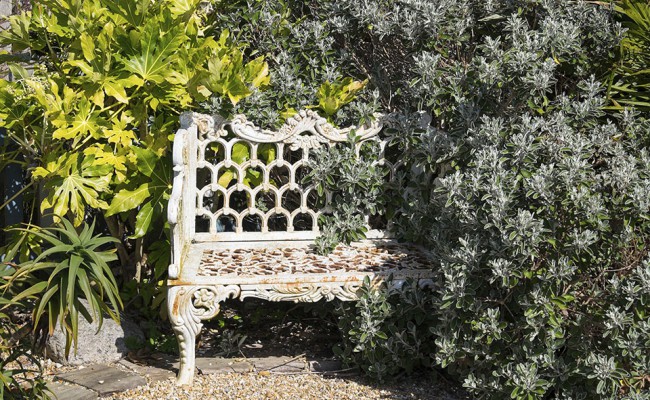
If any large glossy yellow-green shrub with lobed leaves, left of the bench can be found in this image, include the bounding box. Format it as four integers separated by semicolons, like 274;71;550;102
0;0;269;267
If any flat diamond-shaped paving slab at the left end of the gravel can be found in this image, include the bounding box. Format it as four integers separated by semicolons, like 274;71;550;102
56;364;147;396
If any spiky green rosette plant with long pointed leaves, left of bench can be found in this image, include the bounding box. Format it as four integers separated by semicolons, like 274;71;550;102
6;220;122;355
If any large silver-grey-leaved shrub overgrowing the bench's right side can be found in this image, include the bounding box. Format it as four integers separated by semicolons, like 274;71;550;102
216;0;650;399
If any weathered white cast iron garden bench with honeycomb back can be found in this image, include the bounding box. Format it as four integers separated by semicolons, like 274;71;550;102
167;111;432;384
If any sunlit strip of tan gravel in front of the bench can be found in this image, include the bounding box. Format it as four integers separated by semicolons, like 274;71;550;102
109;373;461;400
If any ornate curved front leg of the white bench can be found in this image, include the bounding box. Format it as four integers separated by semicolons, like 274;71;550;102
167;285;240;385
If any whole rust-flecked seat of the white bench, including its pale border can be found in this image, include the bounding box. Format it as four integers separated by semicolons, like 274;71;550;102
170;241;432;285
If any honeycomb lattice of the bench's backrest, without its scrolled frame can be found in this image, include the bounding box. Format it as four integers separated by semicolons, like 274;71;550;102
197;138;327;233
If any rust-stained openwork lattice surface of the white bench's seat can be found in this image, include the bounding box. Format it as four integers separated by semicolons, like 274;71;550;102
198;244;431;277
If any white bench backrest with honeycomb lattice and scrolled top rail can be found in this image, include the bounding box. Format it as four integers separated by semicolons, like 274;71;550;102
184;111;396;241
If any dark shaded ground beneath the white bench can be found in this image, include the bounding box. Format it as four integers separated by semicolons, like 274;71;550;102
138;299;469;400
